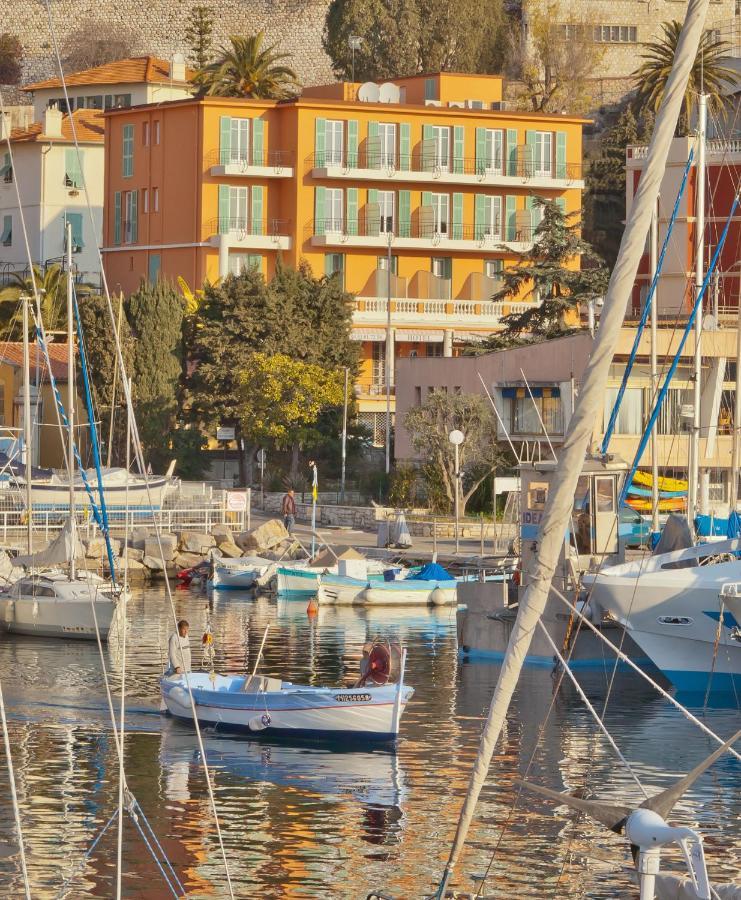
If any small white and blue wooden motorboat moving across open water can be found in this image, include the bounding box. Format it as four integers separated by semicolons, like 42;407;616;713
160;643;414;742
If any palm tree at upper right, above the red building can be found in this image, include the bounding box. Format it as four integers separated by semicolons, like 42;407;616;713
631;21;738;133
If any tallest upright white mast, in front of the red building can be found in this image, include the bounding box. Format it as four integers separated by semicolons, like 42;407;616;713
687;93;708;523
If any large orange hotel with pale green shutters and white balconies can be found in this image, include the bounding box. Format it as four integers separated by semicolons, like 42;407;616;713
103;73;584;443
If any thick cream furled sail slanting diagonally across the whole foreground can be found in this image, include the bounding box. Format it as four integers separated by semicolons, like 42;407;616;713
437;0;709;884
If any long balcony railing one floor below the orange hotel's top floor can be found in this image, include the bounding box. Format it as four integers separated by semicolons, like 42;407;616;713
304;213;535;247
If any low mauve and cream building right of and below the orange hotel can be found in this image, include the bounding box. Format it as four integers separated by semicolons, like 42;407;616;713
395;325;737;515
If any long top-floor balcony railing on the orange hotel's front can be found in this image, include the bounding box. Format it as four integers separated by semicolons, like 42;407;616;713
306;142;583;182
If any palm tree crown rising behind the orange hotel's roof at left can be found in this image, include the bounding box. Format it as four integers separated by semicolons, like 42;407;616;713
194;31;299;100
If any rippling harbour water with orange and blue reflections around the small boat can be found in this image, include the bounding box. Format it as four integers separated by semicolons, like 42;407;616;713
0;590;741;900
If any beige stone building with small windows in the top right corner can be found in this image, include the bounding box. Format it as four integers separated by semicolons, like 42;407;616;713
522;0;741;105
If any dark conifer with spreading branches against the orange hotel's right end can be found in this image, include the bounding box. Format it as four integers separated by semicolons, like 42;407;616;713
485;197;609;350
